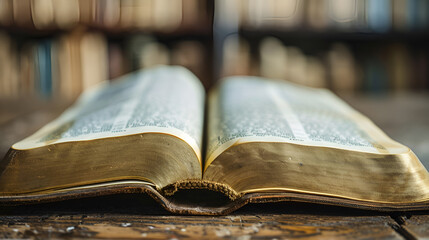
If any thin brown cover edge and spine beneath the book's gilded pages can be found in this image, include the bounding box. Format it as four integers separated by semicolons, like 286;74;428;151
0;184;429;215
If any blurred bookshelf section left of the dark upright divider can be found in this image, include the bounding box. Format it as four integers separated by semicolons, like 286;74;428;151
0;0;214;102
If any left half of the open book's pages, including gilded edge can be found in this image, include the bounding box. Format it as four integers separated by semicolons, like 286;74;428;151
0;67;205;195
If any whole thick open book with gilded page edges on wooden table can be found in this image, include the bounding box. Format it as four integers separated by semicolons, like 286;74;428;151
0;67;429;214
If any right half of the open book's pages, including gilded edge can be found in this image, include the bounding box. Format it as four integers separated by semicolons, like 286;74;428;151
203;77;429;203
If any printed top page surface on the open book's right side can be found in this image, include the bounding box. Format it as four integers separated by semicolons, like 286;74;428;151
205;77;409;168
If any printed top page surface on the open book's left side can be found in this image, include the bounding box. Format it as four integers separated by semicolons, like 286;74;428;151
12;67;205;161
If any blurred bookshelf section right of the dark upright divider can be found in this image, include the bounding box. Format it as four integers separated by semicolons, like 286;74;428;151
214;0;429;94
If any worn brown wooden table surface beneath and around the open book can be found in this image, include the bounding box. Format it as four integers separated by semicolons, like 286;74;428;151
0;93;429;239
